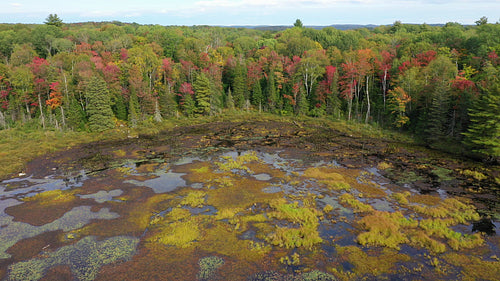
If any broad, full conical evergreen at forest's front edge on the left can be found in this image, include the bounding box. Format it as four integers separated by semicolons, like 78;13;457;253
86;76;115;132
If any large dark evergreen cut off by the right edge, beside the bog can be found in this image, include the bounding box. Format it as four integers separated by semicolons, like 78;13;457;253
464;83;500;158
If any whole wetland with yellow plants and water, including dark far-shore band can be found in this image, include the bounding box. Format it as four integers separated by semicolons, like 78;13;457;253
0;119;500;280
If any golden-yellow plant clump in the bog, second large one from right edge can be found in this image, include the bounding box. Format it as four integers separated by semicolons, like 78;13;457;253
357;211;418;249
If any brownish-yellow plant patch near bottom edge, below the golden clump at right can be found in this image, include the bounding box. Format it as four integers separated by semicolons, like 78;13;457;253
334;246;411;279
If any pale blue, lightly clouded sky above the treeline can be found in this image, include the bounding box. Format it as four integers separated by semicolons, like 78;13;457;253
0;0;500;25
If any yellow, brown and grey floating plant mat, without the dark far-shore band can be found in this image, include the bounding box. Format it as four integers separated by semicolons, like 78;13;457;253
0;148;500;280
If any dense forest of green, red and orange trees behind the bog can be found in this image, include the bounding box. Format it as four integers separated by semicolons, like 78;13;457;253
0;15;500;160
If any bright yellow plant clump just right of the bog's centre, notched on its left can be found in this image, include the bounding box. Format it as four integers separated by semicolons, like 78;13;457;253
266;199;323;249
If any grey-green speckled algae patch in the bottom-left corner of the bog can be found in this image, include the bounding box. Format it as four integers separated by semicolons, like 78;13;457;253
8;236;139;281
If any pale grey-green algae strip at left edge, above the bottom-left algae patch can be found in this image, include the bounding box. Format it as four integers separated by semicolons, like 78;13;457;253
0;206;119;259
